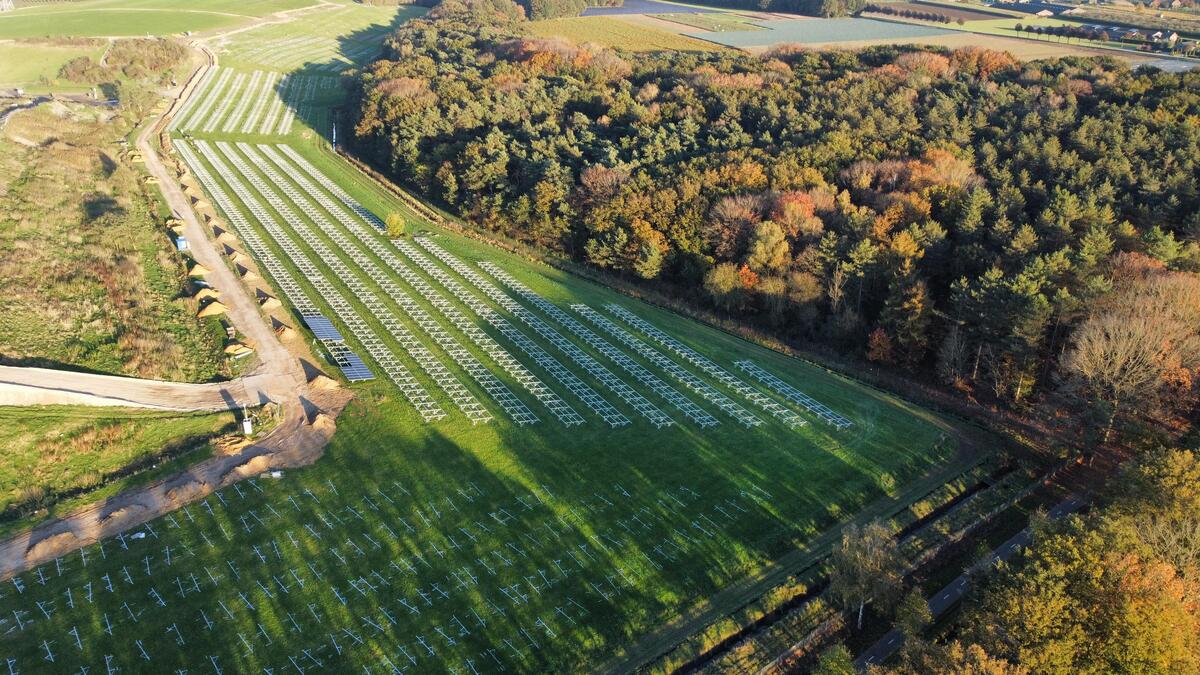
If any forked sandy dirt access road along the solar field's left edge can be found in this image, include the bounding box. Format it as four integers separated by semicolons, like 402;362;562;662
0;32;352;580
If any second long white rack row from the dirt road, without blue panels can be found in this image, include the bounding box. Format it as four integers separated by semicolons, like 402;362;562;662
188;142;446;422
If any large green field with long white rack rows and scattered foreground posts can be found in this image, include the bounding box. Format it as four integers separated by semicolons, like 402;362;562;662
0;121;965;673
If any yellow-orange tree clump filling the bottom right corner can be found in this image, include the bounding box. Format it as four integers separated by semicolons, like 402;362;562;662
964;473;1200;673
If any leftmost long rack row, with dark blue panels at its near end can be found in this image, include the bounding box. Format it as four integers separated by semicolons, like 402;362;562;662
175;141;374;382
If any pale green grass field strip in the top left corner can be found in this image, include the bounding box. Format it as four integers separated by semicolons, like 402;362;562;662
0;0;313;38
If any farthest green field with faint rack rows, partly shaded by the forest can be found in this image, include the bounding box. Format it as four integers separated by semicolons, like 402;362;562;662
215;5;425;73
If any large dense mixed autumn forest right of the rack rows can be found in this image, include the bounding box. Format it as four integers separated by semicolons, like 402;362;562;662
353;0;1200;441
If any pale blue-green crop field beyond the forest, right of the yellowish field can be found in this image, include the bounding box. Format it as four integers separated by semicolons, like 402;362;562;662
685;18;949;47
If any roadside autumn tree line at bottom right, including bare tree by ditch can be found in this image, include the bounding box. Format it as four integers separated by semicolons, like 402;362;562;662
859;448;1200;675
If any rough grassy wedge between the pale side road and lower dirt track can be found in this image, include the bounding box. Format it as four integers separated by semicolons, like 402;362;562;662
0;406;234;536
